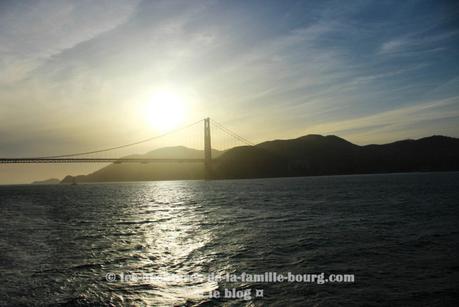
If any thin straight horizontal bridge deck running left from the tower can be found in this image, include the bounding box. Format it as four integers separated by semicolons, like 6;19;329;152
0;158;204;164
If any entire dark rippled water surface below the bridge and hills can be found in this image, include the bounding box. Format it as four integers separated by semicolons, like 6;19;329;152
0;173;459;306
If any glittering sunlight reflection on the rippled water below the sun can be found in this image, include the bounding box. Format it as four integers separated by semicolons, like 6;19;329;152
107;182;218;305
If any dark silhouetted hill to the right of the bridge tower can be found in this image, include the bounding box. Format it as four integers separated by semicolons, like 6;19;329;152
215;135;459;178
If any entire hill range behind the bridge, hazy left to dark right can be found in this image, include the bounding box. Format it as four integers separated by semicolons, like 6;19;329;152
62;135;459;183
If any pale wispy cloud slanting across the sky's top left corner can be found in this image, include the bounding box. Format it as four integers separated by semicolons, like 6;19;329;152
0;1;137;85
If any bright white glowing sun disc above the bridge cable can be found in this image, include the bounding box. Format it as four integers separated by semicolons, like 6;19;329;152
146;91;185;132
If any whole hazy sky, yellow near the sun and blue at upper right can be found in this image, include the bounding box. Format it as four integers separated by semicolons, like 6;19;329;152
0;0;459;183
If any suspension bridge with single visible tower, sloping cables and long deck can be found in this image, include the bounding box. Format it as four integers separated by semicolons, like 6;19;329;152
0;117;254;178
